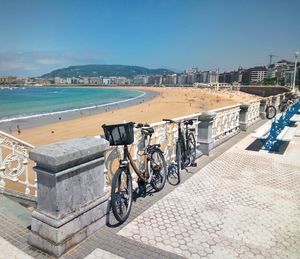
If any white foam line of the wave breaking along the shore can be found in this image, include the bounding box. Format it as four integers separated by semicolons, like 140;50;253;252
0;91;146;123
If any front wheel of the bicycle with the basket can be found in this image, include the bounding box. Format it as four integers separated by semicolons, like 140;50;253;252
111;168;132;223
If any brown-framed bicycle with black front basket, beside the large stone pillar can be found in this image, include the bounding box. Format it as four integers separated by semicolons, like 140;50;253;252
102;122;167;223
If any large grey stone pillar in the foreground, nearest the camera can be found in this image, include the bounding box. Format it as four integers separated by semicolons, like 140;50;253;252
28;137;109;257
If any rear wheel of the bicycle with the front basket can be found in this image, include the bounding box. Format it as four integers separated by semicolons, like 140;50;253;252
150;149;167;191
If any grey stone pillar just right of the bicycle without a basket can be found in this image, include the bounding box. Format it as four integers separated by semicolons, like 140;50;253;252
198;112;216;155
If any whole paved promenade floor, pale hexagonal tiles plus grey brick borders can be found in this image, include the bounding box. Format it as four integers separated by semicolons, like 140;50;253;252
0;122;300;259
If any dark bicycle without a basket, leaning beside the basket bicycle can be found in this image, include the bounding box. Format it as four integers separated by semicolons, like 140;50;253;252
163;119;197;185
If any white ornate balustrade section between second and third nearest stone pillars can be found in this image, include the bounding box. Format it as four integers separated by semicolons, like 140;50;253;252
212;105;240;141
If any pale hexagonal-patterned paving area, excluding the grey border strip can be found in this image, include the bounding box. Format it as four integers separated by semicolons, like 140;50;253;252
118;123;300;259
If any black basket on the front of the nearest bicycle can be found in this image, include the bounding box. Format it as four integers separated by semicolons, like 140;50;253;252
102;122;134;146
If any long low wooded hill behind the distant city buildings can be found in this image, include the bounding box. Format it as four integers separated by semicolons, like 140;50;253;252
42;65;174;78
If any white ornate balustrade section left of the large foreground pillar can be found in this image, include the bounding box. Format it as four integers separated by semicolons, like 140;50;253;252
0;131;37;197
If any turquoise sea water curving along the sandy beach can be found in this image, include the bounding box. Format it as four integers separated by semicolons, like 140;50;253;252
0;87;145;123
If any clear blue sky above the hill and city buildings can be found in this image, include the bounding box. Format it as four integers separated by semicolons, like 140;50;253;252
0;0;300;76
